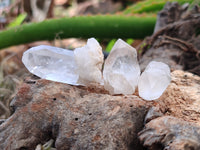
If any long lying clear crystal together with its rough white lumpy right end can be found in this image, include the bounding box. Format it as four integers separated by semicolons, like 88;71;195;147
22;38;103;85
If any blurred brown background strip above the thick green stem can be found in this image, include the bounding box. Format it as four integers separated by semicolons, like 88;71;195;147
0;0;139;29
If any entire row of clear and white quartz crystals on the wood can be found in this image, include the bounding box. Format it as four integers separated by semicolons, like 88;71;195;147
22;38;171;100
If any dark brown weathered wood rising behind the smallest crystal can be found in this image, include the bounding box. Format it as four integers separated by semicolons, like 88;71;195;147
138;3;200;75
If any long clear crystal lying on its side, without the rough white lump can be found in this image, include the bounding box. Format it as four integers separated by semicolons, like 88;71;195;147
22;45;78;85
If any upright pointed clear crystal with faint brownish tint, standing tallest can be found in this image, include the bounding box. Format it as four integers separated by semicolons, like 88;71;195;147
103;39;140;95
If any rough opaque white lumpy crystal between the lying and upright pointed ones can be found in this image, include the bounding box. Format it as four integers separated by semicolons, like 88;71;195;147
74;38;104;85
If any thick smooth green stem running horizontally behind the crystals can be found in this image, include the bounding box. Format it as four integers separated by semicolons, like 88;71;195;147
0;15;156;49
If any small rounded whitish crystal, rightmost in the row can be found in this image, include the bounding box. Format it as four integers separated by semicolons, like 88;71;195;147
138;61;171;100
